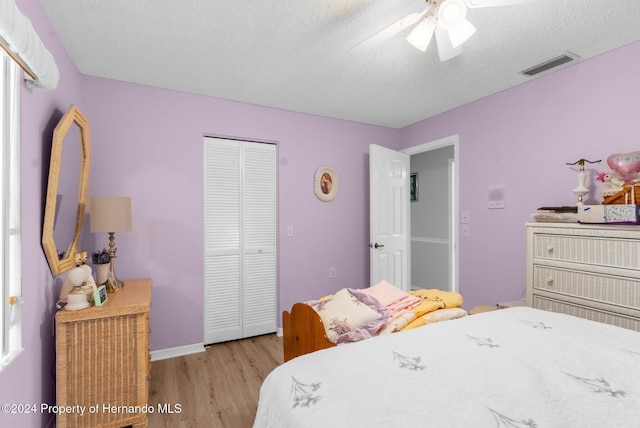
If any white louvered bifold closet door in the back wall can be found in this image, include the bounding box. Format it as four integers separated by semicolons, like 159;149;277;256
204;137;276;344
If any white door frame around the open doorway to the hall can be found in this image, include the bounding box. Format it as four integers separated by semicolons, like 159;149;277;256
400;134;460;292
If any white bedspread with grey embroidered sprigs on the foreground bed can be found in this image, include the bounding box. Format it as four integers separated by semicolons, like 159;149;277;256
254;307;640;428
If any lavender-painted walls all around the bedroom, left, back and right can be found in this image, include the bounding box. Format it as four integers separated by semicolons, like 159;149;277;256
5;0;640;427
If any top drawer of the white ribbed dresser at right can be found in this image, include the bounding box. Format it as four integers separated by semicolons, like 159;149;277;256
533;233;640;270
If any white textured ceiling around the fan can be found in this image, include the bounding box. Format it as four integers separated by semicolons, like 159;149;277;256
40;0;640;128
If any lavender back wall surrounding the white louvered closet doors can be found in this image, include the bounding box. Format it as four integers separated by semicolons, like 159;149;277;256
83;77;399;350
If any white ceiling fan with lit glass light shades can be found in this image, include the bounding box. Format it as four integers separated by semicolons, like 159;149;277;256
354;0;535;61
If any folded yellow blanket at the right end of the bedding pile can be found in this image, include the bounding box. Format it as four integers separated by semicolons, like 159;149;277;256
383;289;466;333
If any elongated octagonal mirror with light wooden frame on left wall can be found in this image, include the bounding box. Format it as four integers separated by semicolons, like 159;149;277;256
42;106;91;276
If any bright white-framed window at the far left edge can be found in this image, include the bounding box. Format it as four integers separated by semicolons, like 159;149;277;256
0;50;22;372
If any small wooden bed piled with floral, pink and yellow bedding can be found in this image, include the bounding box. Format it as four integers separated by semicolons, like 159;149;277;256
282;281;467;361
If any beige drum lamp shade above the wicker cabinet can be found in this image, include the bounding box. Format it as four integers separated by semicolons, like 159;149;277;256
89;196;131;233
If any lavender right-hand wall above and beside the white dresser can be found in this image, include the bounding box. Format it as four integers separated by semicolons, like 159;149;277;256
400;42;640;307
